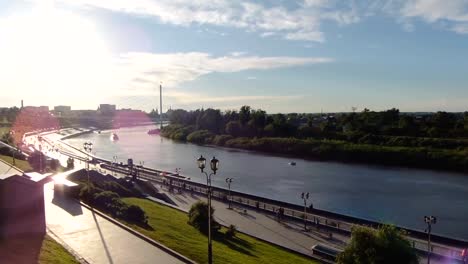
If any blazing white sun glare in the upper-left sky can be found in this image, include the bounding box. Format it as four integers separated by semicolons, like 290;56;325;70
0;7;111;99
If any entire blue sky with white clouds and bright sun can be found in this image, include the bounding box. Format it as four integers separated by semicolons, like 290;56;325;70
0;0;468;113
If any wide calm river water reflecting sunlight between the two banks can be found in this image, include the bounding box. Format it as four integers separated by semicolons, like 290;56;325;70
66;126;468;240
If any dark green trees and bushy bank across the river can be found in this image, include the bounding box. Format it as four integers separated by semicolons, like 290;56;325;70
162;106;468;171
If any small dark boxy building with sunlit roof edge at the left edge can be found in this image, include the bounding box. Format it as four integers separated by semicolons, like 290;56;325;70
0;172;50;238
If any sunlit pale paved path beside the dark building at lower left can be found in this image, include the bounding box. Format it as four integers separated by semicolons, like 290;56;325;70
44;182;182;264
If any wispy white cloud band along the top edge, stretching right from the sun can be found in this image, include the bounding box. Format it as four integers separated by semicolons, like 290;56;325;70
44;0;359;42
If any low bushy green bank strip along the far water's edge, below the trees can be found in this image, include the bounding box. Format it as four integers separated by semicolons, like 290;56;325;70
161;125;468;173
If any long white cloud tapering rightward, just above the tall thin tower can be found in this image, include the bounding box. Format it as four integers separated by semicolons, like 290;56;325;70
117;52;333;87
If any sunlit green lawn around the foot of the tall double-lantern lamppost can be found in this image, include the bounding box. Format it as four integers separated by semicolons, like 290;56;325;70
123;198;317;264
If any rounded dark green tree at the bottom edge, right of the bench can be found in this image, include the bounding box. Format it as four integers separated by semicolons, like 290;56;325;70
337;225;419;264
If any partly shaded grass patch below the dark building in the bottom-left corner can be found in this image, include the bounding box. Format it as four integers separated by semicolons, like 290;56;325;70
0;235;79;264
